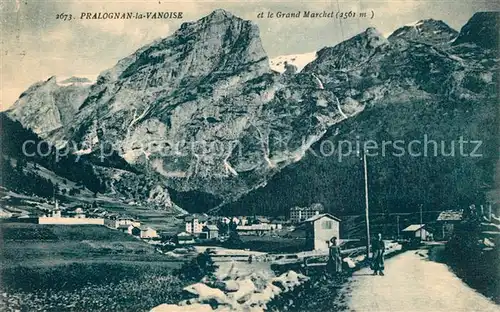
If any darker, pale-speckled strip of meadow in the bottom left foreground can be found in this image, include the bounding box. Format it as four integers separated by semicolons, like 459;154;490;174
0;263;183;311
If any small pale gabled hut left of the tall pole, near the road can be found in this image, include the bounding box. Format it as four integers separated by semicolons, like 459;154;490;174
303;213;341;250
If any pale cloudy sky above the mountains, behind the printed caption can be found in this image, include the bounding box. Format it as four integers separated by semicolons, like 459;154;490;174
0;0;500;110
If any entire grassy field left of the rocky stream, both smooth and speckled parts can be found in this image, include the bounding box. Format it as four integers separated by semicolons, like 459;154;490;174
0;223;188;311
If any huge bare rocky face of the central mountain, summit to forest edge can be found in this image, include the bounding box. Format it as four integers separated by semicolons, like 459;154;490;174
63;10;363;202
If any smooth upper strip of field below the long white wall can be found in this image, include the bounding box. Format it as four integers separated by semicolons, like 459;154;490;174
0;223;175;266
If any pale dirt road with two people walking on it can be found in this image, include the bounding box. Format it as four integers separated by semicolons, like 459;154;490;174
346;251;500;312
